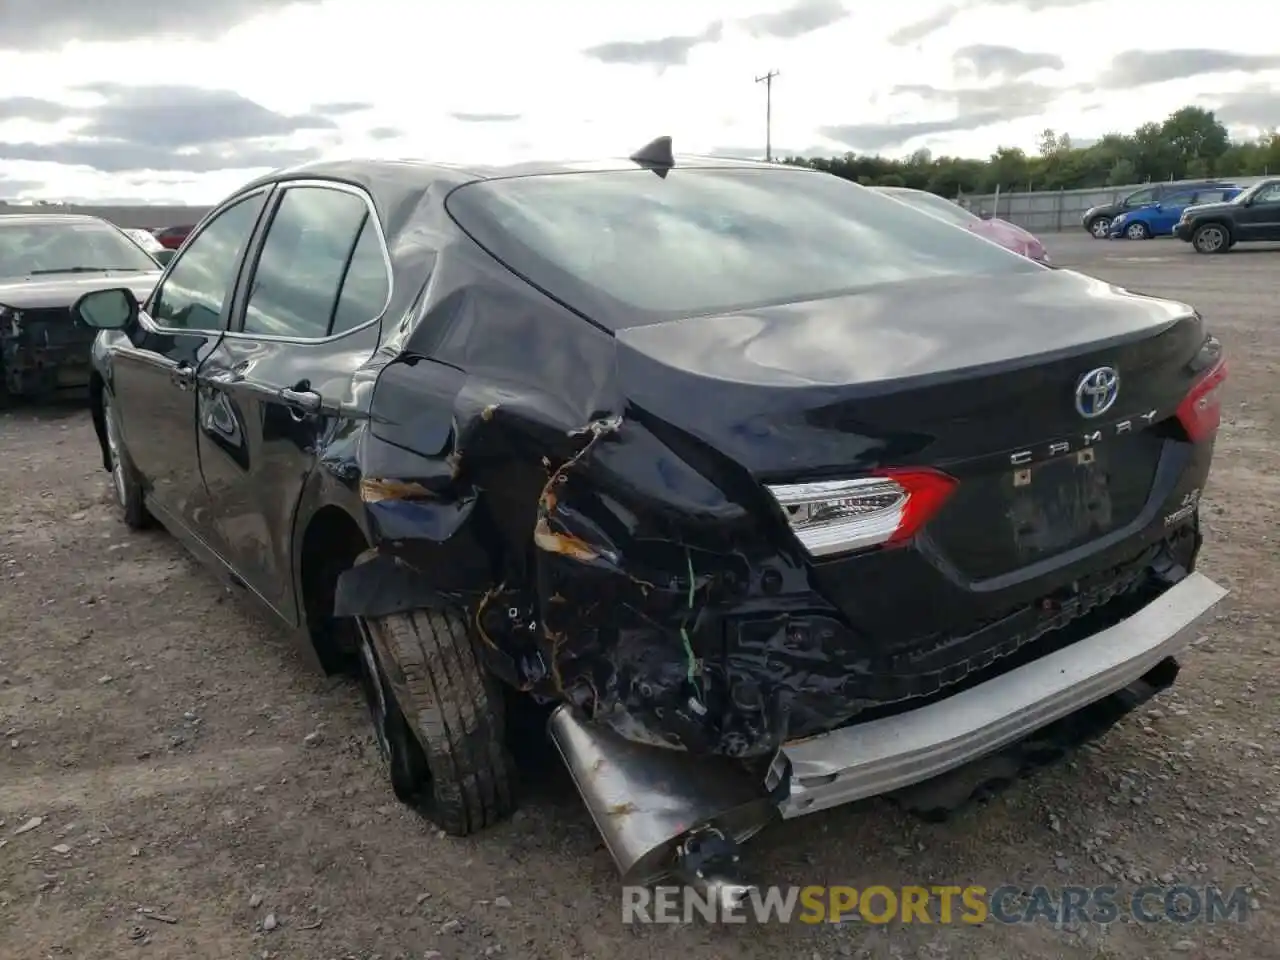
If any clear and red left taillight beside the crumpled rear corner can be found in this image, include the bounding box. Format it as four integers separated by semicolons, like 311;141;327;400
768;470;956;557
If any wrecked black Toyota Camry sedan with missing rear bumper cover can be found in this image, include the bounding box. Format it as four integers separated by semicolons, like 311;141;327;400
77;146;1226;890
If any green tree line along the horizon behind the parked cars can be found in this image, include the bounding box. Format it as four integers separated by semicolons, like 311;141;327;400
783;106;1280;197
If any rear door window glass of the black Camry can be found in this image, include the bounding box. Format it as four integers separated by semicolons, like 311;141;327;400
243;187;380;338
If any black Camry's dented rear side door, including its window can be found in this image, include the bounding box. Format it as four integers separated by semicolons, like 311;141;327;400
198;180;390;623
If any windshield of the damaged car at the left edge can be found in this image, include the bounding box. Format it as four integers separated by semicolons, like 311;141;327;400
0;219;156;279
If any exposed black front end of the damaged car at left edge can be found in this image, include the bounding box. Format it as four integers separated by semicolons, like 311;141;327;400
0;306;97;397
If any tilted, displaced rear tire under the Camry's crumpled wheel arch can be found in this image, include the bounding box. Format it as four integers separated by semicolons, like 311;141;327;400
365;611;516;837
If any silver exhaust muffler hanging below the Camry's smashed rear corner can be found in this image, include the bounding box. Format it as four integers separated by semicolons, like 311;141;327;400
549;704;781;909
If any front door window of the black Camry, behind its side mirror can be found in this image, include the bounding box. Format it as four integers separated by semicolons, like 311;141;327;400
151;192;266;330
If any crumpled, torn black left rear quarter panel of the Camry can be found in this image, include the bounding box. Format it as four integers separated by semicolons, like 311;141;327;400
337;229;865;756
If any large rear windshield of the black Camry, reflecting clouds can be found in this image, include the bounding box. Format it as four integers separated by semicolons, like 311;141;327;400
447;166;1041;329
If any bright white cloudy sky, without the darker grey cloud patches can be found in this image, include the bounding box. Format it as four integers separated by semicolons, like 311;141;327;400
0;0;1280;202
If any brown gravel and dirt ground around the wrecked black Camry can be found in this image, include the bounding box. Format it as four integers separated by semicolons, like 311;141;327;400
0;234;1280;960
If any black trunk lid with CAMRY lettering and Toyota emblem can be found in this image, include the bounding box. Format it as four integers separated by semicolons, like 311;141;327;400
618;270;1204;581
